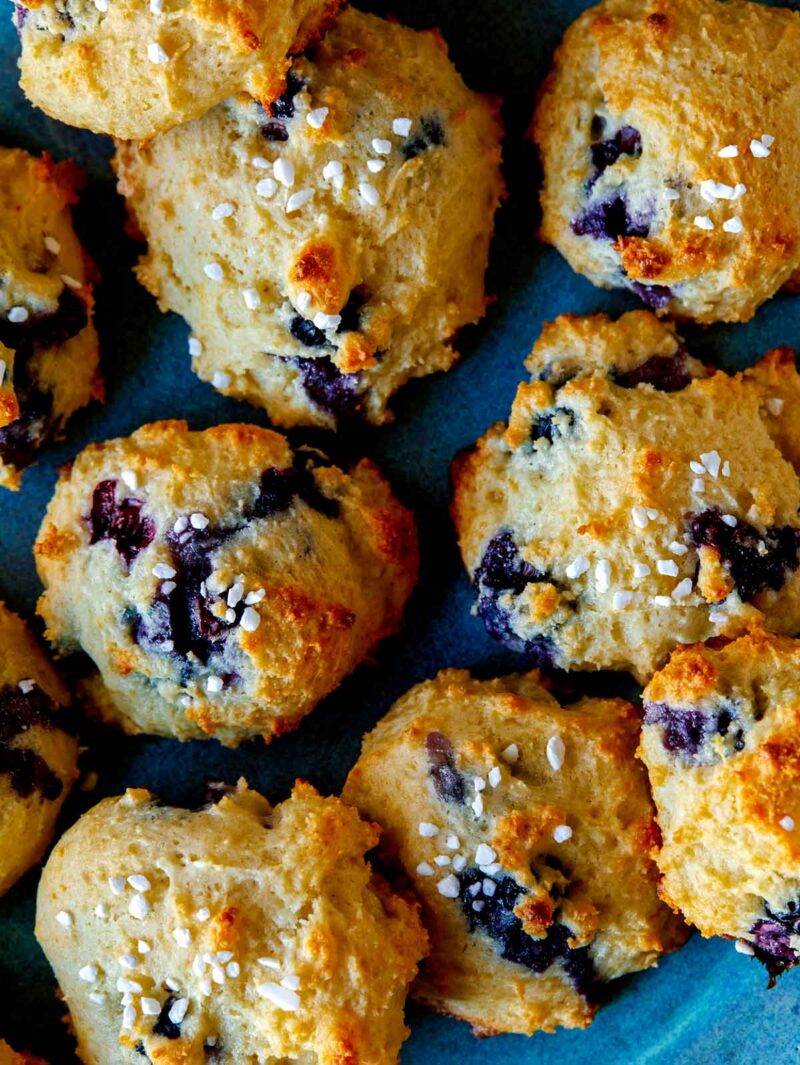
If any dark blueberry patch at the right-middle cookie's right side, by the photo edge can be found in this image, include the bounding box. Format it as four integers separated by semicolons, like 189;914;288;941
688;507;800;603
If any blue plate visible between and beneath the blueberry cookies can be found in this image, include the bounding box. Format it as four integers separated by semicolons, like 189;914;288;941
0;0;800;1065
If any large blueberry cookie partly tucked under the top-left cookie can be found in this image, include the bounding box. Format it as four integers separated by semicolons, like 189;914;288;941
116;11;502;427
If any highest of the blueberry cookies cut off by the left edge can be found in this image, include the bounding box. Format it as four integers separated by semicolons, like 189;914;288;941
0;148;99;489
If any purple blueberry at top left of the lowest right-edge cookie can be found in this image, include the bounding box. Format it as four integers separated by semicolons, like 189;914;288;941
644;702;745;763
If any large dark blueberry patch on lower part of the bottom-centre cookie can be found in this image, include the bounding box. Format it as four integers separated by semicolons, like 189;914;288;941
459;868;601;1001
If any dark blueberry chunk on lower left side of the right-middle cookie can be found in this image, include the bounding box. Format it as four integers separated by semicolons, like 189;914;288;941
474;529;555;666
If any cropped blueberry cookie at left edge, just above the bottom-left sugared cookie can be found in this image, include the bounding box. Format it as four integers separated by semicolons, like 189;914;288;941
0;604;78;895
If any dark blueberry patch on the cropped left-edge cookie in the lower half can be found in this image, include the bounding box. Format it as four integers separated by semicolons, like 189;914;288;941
0;685;72;801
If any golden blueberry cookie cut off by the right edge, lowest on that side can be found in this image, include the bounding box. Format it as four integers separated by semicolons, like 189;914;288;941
639;630;800;979
